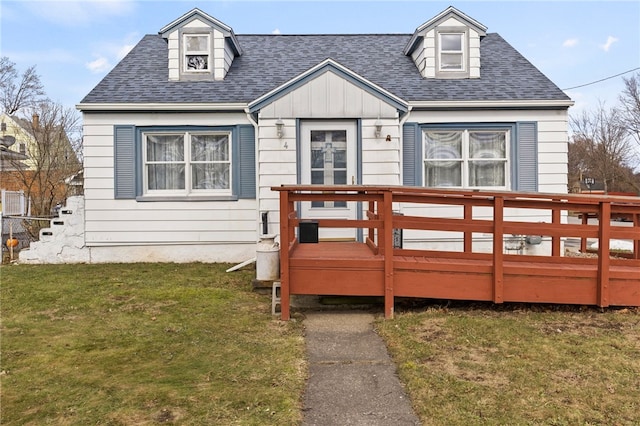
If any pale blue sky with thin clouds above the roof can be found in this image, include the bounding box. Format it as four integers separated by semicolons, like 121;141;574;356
0;0;640;113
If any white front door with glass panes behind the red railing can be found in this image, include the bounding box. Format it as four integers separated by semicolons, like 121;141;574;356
300;121;358;240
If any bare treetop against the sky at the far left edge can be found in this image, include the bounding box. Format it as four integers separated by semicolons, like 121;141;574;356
0;56;44;115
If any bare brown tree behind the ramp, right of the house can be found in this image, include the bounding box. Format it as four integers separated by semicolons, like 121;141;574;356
569;103;637;193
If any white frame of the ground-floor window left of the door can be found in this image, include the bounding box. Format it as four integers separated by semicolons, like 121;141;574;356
142;131;234;197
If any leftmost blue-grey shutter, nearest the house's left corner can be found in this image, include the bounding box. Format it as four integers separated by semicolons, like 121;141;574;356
113;126;137;199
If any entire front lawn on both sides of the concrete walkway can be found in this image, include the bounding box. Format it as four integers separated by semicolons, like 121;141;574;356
0;264;640;426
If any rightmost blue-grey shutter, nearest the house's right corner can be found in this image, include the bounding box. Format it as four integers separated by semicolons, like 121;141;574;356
514;122;538;192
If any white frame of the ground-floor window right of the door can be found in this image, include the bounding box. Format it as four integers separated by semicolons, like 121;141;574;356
422;127;511;190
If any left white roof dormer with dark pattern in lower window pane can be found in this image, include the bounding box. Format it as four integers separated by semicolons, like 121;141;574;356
158;8;242;81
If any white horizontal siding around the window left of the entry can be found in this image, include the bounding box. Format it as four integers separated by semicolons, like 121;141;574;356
84;113;258;261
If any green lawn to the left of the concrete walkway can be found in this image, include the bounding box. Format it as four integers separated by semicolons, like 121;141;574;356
0;264;306;425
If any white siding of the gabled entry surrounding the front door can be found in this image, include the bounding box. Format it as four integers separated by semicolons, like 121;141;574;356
258;71;400;233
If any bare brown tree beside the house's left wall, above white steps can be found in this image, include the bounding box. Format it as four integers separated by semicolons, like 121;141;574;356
4;100;82;216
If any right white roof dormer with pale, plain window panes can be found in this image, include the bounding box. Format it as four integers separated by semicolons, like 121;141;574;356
404;7;487;79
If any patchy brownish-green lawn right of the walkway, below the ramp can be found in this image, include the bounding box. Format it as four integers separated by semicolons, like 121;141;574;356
377;304;640;425
